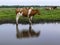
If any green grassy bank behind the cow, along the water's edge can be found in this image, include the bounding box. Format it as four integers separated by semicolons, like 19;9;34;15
0;8;60;23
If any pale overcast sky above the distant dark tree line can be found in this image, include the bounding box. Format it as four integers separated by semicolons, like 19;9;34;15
0;0;60;6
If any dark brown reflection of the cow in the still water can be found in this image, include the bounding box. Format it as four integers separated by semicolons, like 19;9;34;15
16;25;40;38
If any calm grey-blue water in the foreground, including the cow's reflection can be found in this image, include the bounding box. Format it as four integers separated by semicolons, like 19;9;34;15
0;23;60;45
